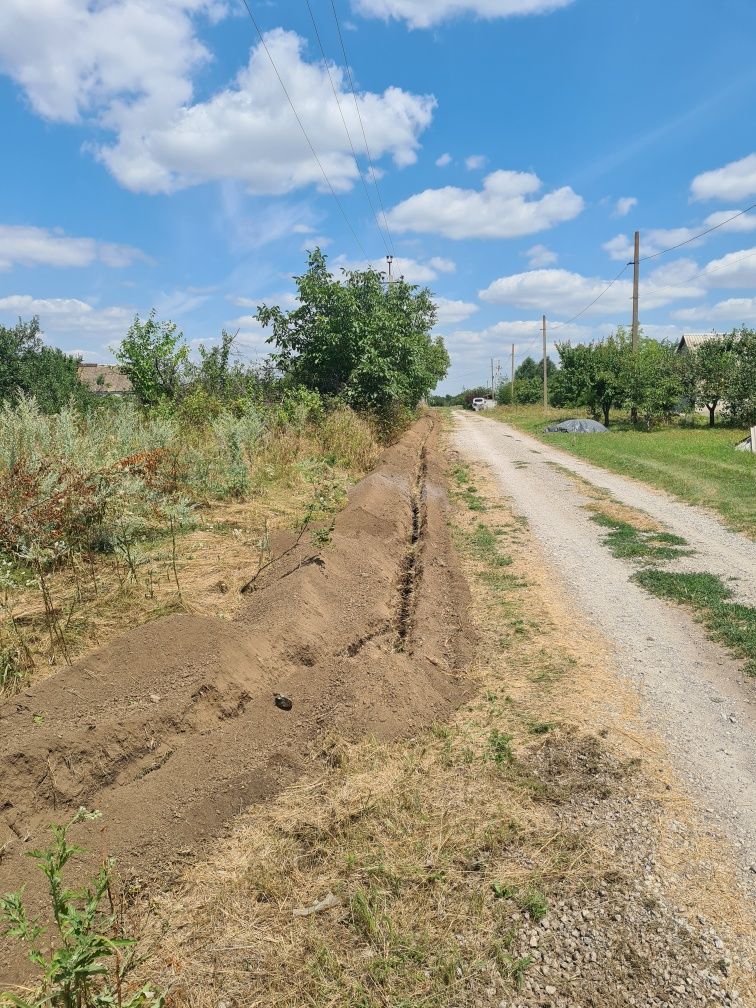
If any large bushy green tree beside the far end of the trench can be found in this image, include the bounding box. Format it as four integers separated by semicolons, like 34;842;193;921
257;249;449;410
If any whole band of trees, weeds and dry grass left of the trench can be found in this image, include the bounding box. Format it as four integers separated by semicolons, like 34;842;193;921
0;251;449;690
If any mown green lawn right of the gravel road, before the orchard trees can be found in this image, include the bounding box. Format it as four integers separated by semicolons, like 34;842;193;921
486;406;756;538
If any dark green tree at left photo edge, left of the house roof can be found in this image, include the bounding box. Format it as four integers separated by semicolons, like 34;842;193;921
0;317;87;413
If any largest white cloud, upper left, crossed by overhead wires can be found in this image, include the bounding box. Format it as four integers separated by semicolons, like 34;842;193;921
0;0;435;195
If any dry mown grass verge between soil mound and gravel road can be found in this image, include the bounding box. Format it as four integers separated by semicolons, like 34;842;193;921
122;435;748;1008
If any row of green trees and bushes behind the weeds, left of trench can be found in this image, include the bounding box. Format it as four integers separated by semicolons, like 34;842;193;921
0;249;450;429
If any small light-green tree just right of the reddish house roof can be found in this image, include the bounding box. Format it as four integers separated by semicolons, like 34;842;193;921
115;309;188;406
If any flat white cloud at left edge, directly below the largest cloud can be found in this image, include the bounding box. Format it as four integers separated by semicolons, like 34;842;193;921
0;224;147;269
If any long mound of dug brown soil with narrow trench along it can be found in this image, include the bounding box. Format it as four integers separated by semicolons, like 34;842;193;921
0;419;470;983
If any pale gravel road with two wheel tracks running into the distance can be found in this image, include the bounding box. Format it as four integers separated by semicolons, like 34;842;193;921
455;413;756;887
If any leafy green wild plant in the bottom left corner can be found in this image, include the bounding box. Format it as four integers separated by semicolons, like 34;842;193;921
0;808;163;1008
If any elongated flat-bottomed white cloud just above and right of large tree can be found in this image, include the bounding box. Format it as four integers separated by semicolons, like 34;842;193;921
388;170;584;238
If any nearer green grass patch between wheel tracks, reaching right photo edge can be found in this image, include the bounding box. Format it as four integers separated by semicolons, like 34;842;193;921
633;571;756;675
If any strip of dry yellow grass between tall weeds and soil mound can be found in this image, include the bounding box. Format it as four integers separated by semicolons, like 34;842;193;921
0;412;380;686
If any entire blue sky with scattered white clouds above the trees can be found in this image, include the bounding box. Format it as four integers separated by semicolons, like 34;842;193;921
0;0;756;390
